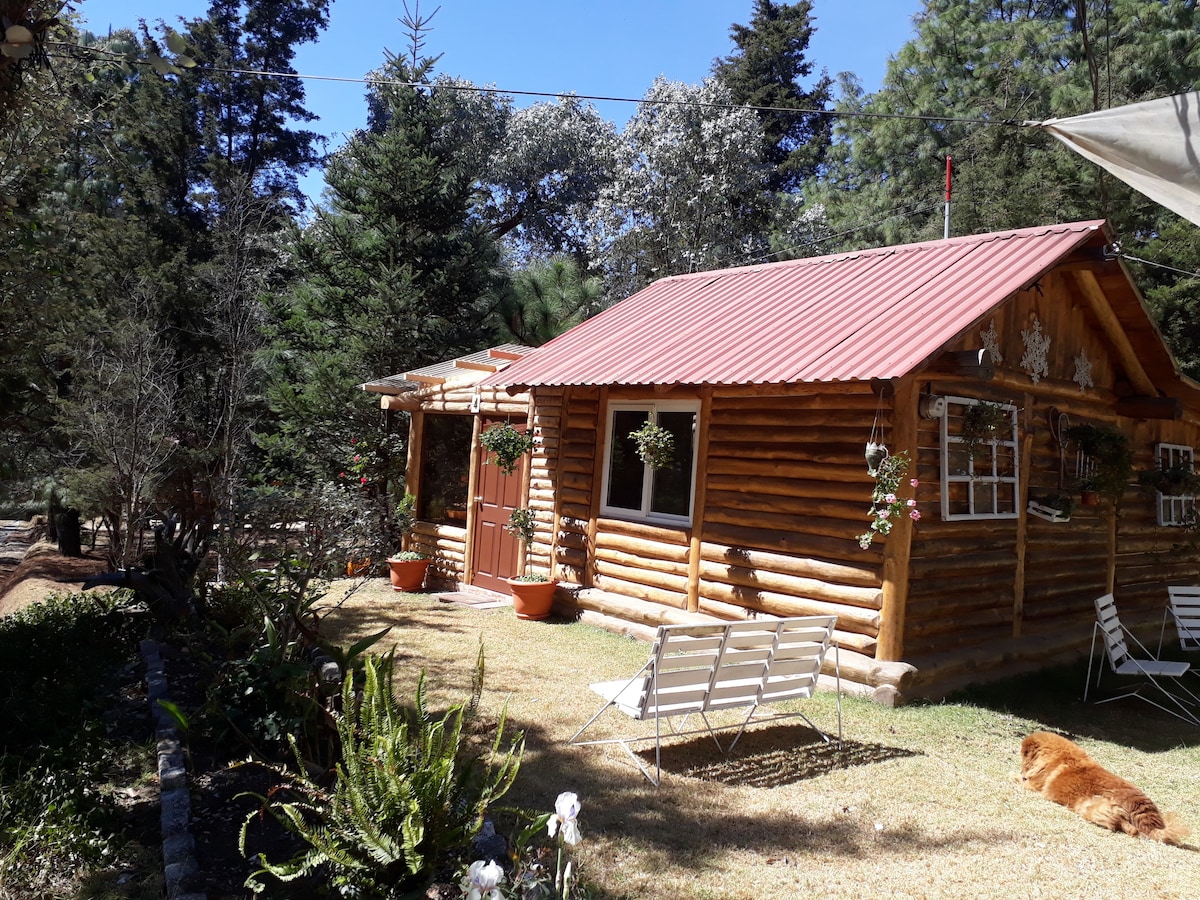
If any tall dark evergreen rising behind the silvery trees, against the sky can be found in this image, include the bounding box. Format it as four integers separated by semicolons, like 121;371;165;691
713;0;833;191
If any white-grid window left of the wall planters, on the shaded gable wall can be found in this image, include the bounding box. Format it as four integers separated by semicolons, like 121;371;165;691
941;397;1020;520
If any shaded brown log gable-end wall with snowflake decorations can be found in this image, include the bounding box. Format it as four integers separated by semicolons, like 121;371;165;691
904;271;1200;671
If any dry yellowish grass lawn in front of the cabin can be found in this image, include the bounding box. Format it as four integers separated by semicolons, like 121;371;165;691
328;580;1200;900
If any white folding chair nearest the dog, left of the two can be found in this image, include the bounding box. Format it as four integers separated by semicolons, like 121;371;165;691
1084;594;1200;725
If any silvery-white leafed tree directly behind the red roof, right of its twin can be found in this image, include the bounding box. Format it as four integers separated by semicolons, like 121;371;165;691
592;76;775;299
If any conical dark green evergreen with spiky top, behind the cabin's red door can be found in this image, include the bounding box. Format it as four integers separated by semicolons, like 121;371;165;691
271;46;502;487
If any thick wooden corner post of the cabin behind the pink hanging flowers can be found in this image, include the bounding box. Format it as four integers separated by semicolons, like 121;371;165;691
875;376;912;660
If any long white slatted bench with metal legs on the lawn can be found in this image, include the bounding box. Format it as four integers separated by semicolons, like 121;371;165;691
568;616;841;785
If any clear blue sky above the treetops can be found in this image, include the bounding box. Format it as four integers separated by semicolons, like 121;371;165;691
78;0;924;200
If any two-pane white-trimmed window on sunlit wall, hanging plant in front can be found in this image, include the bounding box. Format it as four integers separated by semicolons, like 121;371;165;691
600;402;700;524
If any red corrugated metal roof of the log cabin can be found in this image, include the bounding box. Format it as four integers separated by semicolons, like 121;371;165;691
482;220;1104;385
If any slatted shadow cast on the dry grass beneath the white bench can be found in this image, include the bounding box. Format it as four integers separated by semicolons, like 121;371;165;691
634;722;922;787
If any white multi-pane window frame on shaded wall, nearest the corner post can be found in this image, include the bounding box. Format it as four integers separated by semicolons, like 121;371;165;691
941;396;1021;522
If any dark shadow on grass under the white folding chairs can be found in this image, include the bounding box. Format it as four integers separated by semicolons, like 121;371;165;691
947;654;1200;754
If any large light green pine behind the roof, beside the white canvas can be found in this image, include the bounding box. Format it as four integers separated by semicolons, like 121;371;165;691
805;0;1200;372
